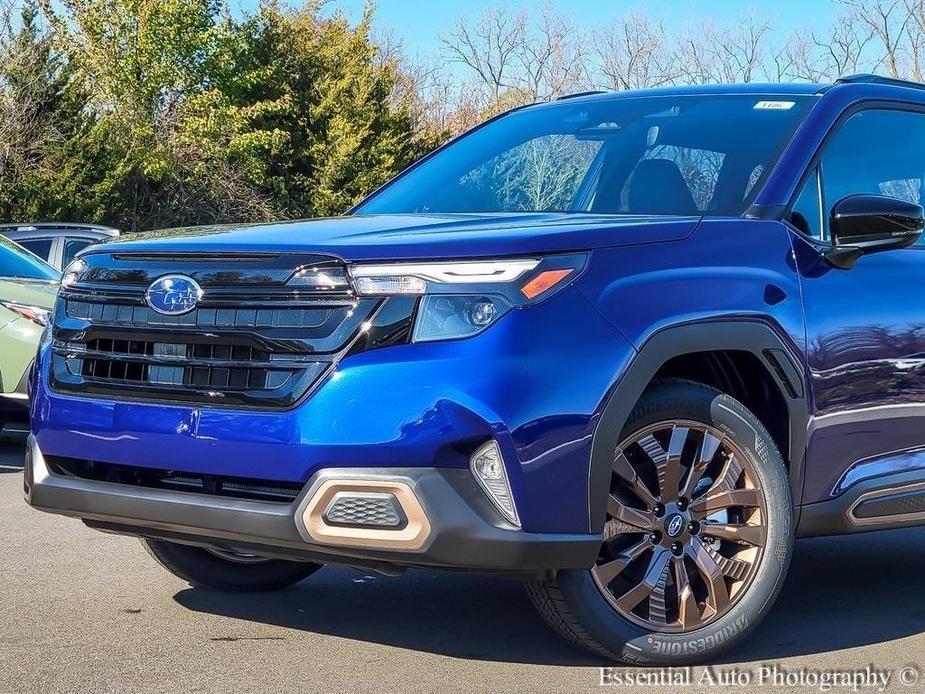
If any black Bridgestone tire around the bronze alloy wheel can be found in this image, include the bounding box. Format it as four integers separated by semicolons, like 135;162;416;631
526;380;794;665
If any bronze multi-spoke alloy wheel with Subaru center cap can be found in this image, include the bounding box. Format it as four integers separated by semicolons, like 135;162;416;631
591;420;767;632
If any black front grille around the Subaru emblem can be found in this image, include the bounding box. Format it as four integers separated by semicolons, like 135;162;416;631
51;252;404;409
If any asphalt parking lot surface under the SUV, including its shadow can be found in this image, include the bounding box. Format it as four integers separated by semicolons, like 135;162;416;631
0;442;925;694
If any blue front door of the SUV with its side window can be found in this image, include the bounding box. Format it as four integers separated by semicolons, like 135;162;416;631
790;108;925;503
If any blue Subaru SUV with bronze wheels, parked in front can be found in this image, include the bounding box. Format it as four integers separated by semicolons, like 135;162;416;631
25;75;925;664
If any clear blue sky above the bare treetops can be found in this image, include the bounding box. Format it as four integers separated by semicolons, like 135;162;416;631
233;0;839;55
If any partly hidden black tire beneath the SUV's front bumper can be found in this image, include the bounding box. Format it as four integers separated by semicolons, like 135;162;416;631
141;538;322;592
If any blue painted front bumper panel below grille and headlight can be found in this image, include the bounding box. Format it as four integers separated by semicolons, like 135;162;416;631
31;287;633;534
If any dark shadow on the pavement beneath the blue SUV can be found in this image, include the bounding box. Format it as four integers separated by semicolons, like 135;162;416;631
175;528;925;666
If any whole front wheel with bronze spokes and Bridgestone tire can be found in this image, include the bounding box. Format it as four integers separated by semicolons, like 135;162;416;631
527;381;794;665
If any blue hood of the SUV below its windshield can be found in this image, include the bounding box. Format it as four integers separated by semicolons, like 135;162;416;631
89;213;700;261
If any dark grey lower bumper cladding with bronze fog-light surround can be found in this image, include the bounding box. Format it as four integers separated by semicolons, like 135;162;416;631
24;436;601;574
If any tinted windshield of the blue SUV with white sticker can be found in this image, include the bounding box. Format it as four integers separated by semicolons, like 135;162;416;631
356;94;815;215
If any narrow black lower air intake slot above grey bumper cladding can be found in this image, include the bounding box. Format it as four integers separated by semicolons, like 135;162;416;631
45;456;302;503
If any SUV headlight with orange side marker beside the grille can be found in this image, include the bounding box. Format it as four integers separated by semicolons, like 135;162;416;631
350;254;587;342
